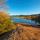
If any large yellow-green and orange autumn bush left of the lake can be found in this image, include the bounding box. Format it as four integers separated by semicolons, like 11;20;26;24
0;12;15;32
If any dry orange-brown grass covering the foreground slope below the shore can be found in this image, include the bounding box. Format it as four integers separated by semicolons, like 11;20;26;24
8;27;40;40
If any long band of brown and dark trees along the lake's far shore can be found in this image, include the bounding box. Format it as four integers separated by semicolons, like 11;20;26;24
12;14;40;23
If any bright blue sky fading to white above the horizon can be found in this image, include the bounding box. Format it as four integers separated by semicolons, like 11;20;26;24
0;0;40;15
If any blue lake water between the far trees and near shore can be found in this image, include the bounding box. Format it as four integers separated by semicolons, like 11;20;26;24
12;18;39;25
